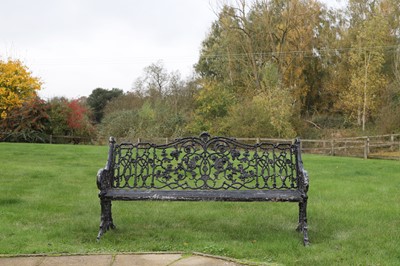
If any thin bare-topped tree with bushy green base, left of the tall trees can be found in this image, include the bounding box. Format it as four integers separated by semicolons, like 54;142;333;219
126;61;195;137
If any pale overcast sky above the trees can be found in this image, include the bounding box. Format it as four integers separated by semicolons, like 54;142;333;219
0;0;343;99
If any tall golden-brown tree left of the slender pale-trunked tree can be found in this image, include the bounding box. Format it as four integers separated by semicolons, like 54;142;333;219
263;0;323;108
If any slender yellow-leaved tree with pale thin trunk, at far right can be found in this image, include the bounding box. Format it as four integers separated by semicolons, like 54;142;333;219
340;1;389;131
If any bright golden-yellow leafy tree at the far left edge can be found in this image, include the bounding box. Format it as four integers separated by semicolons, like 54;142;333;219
0;59;41;118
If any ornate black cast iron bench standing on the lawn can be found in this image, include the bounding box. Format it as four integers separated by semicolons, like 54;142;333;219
97;133;309;245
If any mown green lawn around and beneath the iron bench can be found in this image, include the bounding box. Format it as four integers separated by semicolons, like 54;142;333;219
0;143;400;265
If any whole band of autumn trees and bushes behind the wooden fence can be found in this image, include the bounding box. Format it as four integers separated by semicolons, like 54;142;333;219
0;0;400;142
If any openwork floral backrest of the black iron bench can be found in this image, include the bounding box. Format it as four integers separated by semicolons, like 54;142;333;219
107;133;302;190
